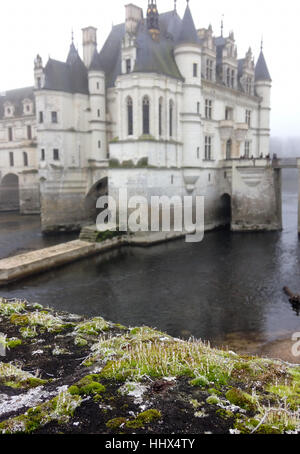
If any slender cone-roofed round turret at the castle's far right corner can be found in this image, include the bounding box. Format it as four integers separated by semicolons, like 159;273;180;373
255;48;272;156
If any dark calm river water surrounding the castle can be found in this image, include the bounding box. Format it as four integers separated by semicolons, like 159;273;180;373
0;172;300;361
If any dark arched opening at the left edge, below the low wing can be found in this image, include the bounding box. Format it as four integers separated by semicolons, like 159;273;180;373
0;173;20;211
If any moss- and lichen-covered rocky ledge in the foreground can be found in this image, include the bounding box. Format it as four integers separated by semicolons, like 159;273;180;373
0;298;300;434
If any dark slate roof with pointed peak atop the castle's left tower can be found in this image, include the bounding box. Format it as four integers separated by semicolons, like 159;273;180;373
44;43;89;94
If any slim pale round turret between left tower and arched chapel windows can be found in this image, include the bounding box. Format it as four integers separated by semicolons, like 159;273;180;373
88;50;108;161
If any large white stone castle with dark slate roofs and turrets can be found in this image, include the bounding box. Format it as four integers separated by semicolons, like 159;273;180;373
0;0;281;232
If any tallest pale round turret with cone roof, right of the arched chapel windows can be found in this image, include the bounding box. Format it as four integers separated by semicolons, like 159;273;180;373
175;0;204;167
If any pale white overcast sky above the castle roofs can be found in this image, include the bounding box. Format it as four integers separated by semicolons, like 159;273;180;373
0;0;300;136
